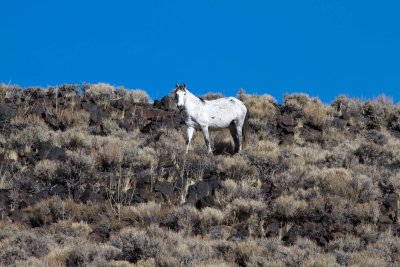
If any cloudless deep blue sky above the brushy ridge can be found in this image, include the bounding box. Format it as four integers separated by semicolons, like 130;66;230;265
0;0;400;102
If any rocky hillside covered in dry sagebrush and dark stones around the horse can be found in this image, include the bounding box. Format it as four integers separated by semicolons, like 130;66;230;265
0;84;400;266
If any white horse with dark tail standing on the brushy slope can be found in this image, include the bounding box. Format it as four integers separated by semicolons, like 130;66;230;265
175;84;248;153
